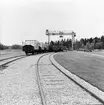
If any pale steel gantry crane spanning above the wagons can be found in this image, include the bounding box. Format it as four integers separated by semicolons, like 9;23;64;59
46;29;76;50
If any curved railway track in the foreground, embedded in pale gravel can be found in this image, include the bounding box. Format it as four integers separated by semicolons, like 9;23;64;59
36;54;103;105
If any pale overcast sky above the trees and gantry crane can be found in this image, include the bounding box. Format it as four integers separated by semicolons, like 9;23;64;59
0;0;104;45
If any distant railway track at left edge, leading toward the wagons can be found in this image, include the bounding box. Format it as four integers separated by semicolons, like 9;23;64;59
0;55;26;70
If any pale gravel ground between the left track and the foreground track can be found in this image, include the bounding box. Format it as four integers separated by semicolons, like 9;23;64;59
0;55;41;105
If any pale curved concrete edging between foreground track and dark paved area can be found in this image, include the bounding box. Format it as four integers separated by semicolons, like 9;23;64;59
50;54;104;104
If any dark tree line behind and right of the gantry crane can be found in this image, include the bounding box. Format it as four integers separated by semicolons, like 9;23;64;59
50;36;104;50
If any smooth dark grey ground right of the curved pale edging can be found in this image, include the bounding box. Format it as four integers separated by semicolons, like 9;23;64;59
54;51;104;91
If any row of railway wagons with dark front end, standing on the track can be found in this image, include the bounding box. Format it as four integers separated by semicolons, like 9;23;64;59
22;40;66;55
